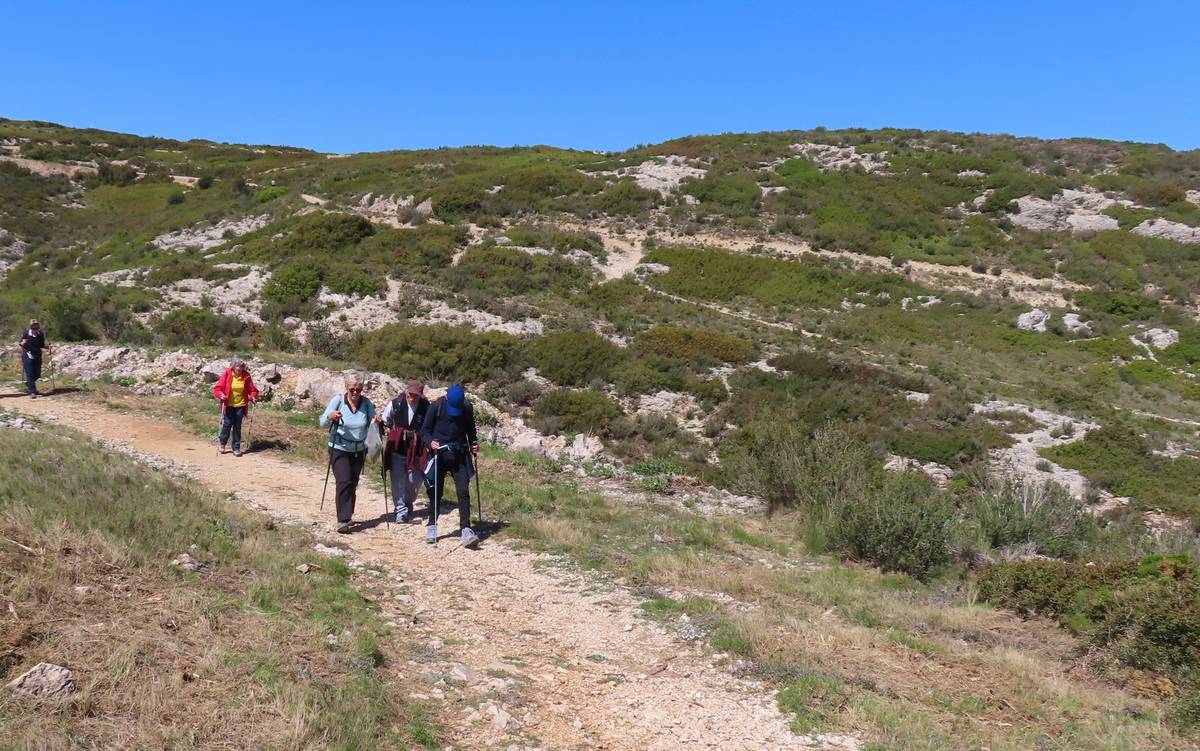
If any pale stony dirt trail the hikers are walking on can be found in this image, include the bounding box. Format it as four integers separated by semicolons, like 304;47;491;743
7;396;816;750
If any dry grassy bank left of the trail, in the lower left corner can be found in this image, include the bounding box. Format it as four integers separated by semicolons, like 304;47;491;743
0;422;433;749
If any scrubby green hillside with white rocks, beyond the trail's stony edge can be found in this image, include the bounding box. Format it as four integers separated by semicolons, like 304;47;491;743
0;121;1200;518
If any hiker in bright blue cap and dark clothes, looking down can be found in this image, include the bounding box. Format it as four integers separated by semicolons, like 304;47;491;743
421;384;479;547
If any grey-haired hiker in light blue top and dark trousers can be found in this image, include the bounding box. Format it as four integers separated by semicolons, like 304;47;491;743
320;376;380;534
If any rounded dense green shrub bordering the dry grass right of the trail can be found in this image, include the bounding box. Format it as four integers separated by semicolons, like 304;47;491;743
828;473;955;581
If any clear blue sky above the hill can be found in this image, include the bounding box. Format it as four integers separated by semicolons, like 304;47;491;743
0;0;1200;151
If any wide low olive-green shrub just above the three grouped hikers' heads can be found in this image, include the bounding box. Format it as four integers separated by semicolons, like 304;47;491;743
358;324;521;383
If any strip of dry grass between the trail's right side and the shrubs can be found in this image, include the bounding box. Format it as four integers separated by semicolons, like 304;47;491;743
485;443;1198;751
